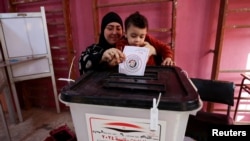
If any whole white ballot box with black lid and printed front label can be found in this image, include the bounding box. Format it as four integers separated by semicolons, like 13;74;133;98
59;66;202;141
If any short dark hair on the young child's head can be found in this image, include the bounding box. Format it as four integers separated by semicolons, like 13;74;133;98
125;11;148;31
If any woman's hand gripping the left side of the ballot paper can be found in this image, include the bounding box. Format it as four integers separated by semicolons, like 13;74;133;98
101;48;125;66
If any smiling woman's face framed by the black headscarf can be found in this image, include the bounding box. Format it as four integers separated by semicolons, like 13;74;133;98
104;22;123;45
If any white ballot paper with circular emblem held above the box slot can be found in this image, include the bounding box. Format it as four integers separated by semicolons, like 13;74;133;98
119;46;149;76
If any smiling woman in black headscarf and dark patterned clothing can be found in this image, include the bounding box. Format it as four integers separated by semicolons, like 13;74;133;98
79;12;125;75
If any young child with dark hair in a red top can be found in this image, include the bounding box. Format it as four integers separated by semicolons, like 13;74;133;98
116;12;174;66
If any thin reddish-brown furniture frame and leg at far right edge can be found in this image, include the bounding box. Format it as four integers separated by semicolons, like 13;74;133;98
234;74;250;120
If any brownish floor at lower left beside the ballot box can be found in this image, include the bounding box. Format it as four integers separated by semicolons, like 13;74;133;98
0;108;74;141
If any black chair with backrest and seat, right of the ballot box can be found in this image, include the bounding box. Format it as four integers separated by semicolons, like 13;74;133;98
185;78;235;141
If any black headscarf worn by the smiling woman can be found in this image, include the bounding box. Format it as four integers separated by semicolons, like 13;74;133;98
98;12;123;50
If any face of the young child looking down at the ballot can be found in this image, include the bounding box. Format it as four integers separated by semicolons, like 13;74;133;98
125;25;147;46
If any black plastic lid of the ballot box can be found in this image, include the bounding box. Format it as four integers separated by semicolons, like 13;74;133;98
60;66;199;111
